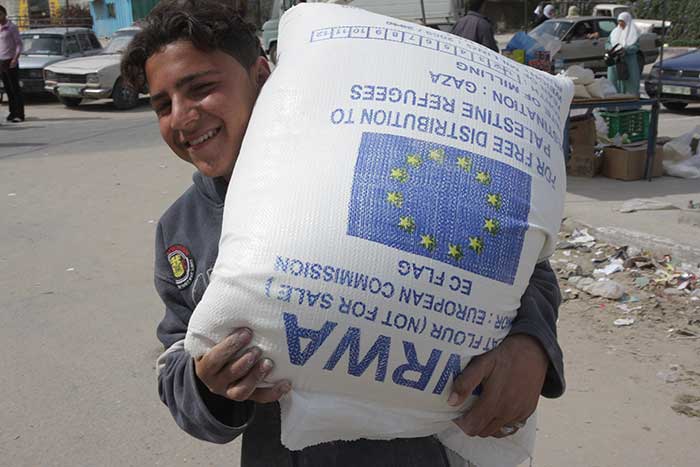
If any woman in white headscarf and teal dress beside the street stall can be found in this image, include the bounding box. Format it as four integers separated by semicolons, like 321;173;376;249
605;12;643;96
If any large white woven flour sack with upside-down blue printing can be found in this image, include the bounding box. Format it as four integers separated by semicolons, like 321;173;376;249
185;4;573;467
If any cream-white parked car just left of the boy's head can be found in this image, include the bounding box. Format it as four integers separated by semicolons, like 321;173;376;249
44;27;146;110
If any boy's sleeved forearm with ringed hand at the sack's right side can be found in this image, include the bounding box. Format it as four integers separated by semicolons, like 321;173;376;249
448;262;564;437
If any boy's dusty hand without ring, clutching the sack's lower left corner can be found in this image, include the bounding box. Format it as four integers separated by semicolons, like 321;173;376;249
194;328;292;403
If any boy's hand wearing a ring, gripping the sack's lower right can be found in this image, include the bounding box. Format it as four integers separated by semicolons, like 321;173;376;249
448;334;549;438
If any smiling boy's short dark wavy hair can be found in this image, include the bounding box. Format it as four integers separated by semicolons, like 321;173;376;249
121;0;262;89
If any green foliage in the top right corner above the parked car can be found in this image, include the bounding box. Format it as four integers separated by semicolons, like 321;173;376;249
635;0;700;41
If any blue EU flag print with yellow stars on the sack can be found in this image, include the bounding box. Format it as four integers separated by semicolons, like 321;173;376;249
348;133;532;285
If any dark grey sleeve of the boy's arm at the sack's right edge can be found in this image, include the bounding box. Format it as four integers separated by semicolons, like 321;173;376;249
508;261;566;398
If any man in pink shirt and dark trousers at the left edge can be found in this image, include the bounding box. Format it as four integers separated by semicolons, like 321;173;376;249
0;5;24;123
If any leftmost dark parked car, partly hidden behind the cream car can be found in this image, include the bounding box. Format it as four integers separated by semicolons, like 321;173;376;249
7;28;102;94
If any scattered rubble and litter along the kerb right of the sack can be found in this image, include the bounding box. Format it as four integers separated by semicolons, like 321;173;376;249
550;223;700;338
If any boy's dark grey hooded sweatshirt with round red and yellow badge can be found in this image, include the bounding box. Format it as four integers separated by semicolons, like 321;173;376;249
155;172;564;467
